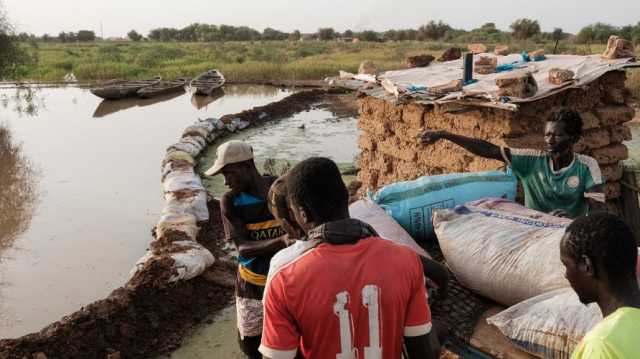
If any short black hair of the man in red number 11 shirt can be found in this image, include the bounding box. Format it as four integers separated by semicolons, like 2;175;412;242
286;157;349;221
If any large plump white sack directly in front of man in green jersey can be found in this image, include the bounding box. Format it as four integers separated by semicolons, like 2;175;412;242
433;199;571;306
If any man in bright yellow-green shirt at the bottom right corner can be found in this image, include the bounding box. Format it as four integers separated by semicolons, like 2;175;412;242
560;213;640;359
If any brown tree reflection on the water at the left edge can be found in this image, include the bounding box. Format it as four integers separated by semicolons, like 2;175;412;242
0;124;38;261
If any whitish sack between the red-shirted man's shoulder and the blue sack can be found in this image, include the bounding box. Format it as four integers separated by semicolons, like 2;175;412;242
349;199;430;258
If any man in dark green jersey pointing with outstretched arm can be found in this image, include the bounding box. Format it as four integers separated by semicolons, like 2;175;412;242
422;110;605;218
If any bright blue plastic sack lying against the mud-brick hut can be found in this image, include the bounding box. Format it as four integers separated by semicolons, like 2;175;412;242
369;171;517;241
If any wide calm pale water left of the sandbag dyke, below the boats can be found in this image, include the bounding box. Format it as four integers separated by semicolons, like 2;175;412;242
0;86;288;338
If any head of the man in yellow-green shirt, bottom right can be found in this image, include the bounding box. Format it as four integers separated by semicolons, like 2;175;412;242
560;212;638;304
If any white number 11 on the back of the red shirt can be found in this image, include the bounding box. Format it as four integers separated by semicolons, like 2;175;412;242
333;285;382;359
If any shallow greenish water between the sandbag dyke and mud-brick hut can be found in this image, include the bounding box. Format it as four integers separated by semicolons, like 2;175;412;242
162;103;359;359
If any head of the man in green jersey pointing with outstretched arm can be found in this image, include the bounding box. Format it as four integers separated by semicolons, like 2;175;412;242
544;109;582;154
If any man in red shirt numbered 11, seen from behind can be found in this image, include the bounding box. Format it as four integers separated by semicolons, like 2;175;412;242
260;158;439;359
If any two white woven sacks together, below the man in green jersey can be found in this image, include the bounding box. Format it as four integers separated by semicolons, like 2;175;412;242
433;199;640;359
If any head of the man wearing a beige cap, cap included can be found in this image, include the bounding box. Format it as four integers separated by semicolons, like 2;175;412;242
205;141;257;192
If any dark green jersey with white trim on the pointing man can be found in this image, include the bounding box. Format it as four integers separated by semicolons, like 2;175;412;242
502;148;605;218
